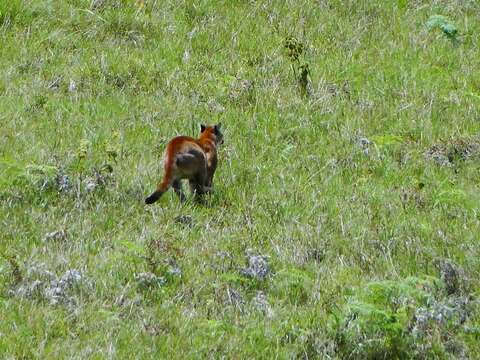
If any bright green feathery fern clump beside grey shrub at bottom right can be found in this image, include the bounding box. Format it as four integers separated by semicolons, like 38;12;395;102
339;278;438;358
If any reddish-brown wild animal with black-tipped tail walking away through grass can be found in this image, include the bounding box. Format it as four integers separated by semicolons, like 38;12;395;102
145;123;223;205
